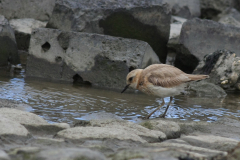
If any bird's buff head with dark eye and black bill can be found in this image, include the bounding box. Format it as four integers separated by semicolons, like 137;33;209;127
121;69;142;93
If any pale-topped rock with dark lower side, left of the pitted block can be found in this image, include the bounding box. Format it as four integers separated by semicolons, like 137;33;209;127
9;18;47;50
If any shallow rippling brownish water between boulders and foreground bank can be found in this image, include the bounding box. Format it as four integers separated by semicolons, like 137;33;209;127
0;70;240;124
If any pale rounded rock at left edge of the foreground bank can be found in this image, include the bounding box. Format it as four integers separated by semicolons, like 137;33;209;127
0;116;29;142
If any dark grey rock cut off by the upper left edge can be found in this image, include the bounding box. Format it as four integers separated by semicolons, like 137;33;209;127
0;14;20;66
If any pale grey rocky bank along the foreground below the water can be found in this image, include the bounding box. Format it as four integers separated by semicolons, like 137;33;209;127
0;100;240;160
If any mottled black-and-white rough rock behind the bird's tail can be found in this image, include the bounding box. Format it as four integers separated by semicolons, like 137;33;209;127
194;50;240;90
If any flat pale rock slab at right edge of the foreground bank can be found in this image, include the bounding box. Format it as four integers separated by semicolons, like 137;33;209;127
181;133;239;151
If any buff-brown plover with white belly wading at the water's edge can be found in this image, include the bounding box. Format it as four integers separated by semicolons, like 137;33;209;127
121;64;209;119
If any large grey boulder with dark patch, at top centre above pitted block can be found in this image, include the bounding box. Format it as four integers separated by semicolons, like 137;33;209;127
47;0;171;63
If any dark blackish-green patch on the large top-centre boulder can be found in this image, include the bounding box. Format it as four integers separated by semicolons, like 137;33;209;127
99;11;167;63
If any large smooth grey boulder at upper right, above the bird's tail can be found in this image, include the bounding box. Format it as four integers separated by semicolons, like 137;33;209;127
176;18;240;70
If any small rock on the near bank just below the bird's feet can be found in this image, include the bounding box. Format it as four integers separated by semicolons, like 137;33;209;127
140;119;181;139
